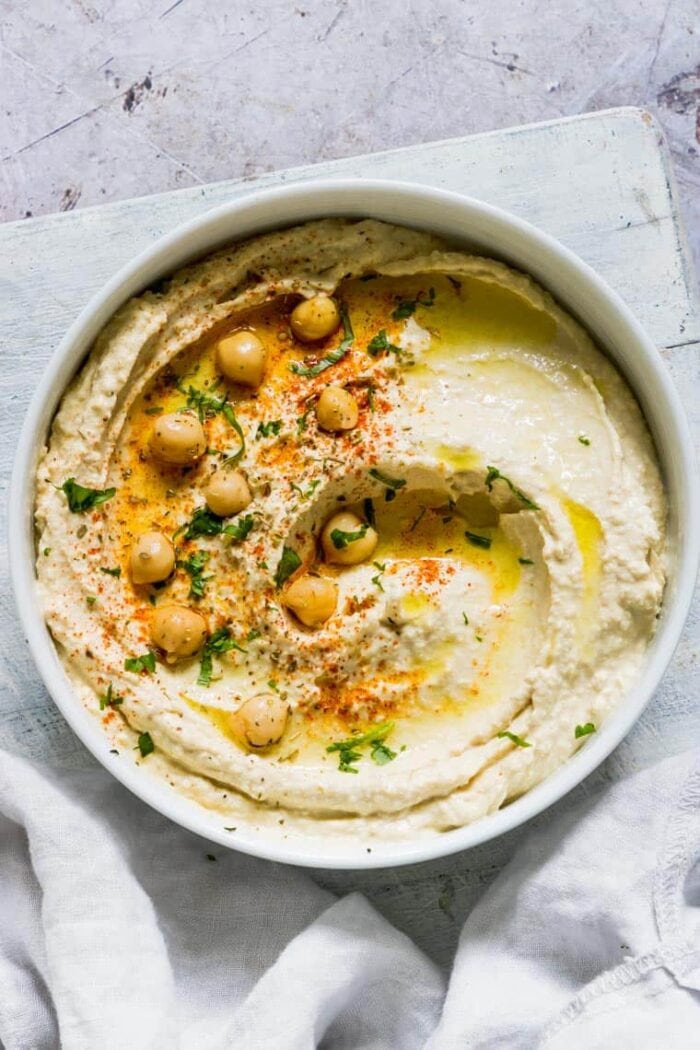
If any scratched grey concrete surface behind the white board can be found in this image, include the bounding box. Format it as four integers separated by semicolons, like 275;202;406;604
0;0;700;268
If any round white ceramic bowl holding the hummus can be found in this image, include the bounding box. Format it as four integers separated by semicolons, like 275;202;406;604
9;180;700;868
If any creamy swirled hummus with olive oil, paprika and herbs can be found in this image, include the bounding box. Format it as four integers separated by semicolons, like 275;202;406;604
36;219;665;841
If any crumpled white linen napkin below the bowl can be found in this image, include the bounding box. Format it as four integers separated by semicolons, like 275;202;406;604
0;753;700;1050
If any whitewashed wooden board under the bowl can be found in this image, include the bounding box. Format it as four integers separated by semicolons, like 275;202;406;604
0;109;700;963
